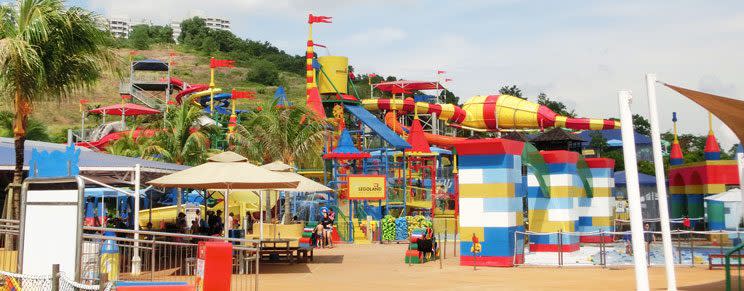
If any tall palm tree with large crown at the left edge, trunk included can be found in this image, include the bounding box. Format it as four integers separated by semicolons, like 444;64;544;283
0;0;117;218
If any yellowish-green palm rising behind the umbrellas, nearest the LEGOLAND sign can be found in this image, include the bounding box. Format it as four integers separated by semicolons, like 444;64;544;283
229;101;325;223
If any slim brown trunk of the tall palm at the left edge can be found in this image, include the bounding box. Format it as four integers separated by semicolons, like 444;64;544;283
12;91;31;219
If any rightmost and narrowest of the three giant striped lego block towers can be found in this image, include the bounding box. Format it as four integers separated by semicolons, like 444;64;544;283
577;158;615;243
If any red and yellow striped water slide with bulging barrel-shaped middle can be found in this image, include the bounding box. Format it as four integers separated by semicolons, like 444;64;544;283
362;95;620;131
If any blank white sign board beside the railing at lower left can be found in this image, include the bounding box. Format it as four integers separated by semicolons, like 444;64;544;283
19;178;85;278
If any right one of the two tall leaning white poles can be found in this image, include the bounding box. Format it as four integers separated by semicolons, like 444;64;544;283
646;74;677;291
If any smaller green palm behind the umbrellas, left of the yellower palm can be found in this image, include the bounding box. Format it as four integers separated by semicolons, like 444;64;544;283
142;103;217;165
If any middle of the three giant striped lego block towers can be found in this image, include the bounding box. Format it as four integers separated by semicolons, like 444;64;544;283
527;151;586;252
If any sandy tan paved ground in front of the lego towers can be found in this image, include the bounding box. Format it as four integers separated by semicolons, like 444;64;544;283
260;244;724;291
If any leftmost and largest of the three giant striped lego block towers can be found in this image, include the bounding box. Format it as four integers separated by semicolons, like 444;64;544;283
455;139;524;267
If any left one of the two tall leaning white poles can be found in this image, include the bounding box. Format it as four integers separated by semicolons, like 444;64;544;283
617;91;649;291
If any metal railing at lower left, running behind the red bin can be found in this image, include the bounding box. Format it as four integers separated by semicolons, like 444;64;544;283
80;227;260;291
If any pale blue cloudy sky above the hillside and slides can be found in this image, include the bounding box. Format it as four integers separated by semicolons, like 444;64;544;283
68;0;744;149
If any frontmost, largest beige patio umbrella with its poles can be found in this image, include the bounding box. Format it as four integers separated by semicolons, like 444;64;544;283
147;151;299;239
